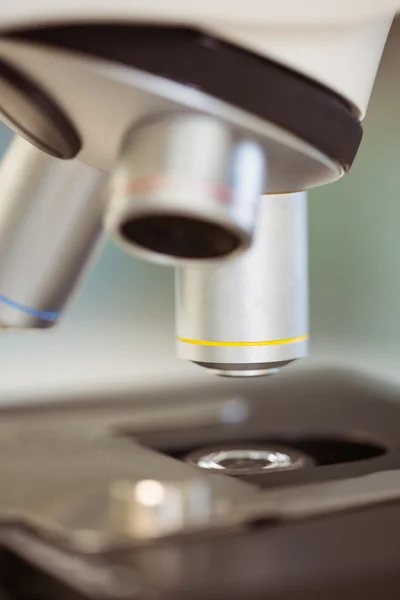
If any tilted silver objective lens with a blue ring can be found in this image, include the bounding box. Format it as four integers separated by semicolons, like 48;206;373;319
0;138;105;328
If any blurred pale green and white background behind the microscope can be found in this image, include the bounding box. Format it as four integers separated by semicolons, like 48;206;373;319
0;21;400;405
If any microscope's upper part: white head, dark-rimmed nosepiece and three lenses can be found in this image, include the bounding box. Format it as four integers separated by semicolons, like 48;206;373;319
0;2;382;377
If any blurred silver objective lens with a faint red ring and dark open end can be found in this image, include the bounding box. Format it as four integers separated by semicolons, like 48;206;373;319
106;113;266;265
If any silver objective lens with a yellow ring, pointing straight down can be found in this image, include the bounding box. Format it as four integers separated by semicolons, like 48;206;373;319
176;192;309;377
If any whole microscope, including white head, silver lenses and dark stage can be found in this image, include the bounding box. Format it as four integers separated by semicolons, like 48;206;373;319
0;0;400;600
